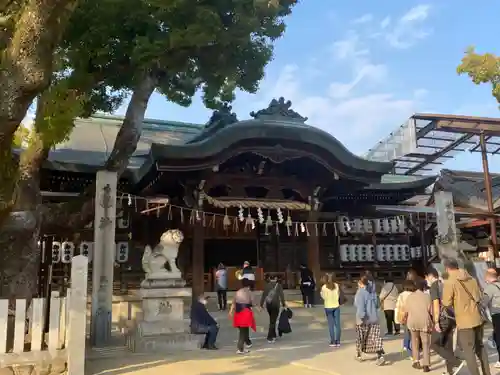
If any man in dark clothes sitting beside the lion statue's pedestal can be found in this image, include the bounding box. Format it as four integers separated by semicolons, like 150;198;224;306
191;295;219;350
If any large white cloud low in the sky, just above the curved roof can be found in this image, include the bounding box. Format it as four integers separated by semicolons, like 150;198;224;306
245;64;423;154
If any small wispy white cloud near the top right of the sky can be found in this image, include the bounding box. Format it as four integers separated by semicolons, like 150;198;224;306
381;4;431;49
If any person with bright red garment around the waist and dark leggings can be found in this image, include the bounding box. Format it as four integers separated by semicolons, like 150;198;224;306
229;279;256;354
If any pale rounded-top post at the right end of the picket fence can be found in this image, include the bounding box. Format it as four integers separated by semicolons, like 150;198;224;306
67;255;88;375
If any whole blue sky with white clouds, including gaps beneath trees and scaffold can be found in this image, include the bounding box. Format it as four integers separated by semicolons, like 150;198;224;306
119;0;500;172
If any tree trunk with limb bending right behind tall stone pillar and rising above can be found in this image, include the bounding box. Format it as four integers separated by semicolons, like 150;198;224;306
0;74;157;298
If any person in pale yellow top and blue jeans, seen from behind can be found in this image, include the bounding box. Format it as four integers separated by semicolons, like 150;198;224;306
320;273;341;348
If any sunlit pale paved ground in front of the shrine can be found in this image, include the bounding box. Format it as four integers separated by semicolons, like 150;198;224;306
86;309;497;375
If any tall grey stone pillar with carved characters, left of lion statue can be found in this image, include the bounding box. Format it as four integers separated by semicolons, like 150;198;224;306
90;171;118;346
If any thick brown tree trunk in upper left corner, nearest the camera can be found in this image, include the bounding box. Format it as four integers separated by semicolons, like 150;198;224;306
0;0;78;228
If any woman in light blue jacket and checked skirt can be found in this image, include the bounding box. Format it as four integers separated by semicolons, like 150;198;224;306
354;274;385;366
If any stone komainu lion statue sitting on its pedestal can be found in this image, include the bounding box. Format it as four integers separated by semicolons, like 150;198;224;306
142;229;184;280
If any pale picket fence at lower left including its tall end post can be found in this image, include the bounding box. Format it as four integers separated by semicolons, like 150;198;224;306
0;255;88;375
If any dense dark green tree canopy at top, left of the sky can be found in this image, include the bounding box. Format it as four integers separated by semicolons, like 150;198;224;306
61;0;296;112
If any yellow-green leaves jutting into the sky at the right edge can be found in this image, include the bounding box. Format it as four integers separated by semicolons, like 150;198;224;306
457;47;500;103
